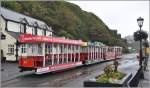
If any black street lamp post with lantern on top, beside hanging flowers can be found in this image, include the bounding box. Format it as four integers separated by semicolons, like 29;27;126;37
137;17;144;68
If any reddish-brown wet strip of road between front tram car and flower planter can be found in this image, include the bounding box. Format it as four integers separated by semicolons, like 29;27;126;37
40;65;107;87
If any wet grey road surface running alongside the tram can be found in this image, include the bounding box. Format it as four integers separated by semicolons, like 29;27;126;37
1;54;141;87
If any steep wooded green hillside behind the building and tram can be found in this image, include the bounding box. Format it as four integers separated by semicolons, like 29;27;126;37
1;1;126;52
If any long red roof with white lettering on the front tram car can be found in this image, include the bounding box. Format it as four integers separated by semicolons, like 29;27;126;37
18;34;85;45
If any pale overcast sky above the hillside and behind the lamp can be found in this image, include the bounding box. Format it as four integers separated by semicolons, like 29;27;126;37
69;1;149;37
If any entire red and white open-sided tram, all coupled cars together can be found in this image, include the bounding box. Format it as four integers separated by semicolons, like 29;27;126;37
17;34;122;74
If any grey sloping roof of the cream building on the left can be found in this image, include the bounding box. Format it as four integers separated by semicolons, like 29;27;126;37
0;7;52;31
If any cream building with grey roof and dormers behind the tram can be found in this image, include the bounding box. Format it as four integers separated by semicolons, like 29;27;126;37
0;7;52;61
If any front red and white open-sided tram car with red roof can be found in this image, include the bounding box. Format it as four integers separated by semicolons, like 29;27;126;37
19;34;84;74
